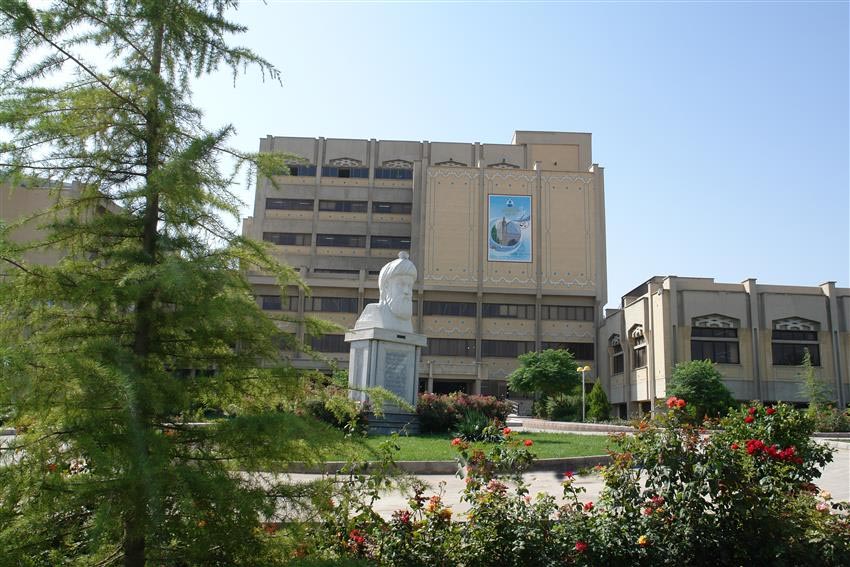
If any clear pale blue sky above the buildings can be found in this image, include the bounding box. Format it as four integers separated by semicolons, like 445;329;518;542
195;1;850;306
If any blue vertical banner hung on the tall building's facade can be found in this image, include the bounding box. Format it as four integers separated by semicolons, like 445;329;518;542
487;195;531;262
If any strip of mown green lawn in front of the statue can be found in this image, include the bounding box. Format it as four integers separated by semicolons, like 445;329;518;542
325;433;608;461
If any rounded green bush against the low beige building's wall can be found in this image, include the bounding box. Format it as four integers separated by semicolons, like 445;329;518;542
667;360;735;419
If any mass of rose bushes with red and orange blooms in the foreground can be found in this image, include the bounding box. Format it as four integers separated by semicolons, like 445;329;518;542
294;400;850;567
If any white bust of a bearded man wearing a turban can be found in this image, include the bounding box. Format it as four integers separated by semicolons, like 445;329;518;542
354;252;416;333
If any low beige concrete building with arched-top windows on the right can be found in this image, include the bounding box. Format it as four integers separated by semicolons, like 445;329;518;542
597;276;850;417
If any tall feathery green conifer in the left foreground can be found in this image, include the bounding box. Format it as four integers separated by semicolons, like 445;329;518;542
0;0;344;566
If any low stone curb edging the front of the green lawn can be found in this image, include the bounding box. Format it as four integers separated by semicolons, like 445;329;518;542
287;455;611;475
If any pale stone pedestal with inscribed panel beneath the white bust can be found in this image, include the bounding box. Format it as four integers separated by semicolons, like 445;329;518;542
345;327;427;434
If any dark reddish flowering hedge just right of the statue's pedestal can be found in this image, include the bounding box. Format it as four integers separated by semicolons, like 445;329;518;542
416;393;511;433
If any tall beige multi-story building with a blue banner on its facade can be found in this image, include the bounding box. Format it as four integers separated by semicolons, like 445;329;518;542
243;132;606;395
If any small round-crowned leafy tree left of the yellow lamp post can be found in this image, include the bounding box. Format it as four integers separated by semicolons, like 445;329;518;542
508;349;581;404
